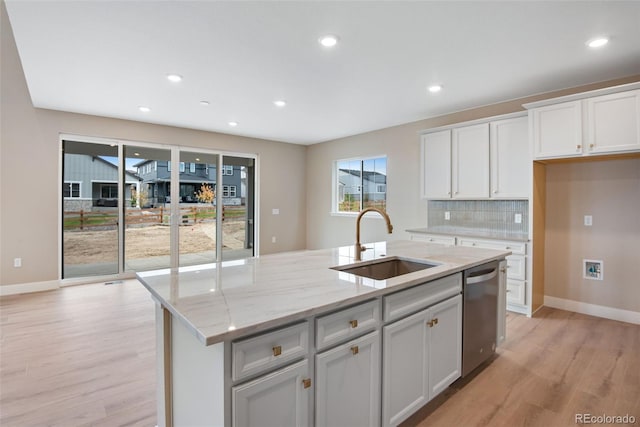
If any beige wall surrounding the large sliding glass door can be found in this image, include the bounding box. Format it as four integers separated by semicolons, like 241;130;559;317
0;3;306;285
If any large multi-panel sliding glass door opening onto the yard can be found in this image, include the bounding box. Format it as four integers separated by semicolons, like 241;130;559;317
61;140;256;279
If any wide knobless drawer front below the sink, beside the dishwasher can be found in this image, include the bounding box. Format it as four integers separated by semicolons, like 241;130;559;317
383;273;462;322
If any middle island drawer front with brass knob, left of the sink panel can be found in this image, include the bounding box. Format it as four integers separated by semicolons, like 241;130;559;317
316;300;380;351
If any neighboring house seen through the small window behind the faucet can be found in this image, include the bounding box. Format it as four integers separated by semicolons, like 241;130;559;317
338;169;387;202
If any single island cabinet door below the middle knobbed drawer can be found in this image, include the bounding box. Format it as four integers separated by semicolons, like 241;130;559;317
316;331;380;427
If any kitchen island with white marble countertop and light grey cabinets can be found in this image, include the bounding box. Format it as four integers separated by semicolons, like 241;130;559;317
138;241;510;426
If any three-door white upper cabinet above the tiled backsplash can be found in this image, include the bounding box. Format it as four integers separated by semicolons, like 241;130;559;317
422;115;531;199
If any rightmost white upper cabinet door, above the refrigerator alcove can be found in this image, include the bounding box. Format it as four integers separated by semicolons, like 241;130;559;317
586;90;640;154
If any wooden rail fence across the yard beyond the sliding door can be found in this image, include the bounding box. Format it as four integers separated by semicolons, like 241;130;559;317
64;206;246;230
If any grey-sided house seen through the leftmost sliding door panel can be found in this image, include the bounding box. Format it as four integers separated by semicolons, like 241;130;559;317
62;154;140;211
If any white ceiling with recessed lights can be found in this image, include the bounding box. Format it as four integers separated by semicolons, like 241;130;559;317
6;0;640;144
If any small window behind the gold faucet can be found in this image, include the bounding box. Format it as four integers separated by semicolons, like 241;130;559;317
334;157;387;213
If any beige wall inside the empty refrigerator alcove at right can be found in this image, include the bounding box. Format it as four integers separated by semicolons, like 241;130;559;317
544;159;640;312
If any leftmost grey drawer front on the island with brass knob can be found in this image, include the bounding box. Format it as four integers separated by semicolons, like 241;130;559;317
231;322;309;381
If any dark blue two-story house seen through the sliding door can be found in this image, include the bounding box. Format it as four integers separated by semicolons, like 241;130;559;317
133;160;244;205
